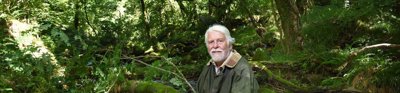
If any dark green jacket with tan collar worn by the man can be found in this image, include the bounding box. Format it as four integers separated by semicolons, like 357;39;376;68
196;51;258;93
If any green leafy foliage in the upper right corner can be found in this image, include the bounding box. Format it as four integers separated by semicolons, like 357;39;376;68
302;0;397;50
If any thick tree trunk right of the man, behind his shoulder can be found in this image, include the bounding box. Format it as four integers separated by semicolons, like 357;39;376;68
275;0;301;54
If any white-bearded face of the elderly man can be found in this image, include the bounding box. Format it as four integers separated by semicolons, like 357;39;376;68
207;31;230;62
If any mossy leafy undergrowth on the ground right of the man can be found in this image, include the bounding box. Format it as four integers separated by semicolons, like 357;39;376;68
253;48;400;93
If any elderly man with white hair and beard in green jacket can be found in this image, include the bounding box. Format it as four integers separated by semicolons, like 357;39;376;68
197;24;258;93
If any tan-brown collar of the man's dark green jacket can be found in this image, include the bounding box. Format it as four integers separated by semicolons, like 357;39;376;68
207;50;242;68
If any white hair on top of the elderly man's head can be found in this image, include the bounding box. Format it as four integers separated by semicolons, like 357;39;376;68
204;24;235;45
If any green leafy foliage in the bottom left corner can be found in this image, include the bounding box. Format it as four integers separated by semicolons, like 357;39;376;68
0;38;60;92
